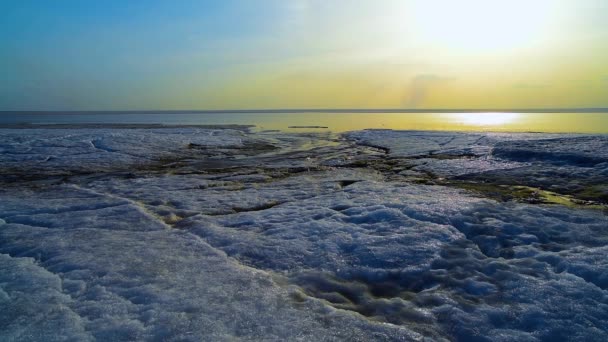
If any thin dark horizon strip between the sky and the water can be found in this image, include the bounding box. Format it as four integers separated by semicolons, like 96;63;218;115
0;107;608;115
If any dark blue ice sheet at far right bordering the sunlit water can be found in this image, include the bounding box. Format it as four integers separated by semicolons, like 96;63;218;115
347;130;608;203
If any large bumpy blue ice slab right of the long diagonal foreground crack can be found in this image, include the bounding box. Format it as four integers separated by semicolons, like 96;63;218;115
184;182;608;341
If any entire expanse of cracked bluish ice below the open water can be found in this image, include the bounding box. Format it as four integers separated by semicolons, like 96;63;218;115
0;128;608;341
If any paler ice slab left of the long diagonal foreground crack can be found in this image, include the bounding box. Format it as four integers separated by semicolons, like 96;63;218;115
0;188;416;341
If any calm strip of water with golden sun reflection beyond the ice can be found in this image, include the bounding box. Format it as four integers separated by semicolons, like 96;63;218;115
0;112;608;133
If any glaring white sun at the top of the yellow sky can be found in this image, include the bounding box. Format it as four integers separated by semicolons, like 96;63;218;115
410;0;555;53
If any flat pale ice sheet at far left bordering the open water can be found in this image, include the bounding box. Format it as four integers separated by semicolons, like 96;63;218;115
0;128;262;173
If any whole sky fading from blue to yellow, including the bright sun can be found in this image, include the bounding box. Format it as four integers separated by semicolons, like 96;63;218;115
0;0;608;111
